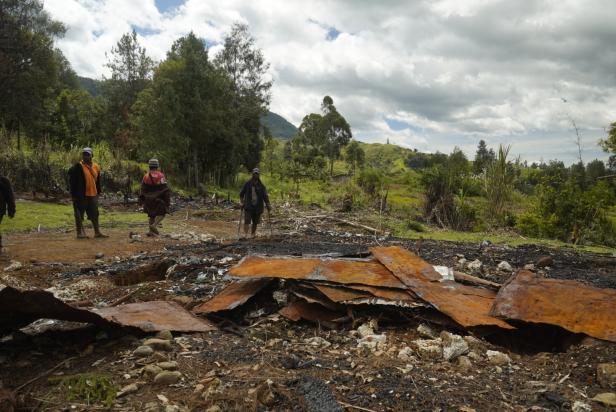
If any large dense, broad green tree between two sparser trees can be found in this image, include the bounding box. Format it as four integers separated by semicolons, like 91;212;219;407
133;32;241;187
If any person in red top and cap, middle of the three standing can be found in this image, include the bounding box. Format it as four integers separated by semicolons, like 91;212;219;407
139;159;171;236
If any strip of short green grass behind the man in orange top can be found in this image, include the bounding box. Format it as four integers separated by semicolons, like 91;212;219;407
1;200;146;232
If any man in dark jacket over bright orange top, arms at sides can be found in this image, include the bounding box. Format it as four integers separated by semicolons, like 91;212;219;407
68;147;107;239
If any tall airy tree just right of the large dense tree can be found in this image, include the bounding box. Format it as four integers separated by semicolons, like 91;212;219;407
214;23;272;170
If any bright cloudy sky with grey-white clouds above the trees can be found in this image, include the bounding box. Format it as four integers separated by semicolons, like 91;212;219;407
44;0;616;163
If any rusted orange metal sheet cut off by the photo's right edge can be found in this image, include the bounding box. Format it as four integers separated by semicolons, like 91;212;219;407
491;271;616;342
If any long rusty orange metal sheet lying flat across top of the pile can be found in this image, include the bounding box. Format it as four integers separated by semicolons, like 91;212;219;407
229;256;406;289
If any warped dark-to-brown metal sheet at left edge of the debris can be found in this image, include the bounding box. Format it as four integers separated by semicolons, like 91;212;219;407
0;287;215;334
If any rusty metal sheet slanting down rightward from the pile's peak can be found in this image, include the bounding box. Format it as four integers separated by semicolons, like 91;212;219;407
371;246;513;329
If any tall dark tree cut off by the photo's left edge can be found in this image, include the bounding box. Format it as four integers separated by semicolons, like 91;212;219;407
0;0;66;146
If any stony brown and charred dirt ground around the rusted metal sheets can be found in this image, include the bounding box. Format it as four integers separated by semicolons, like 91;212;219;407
0;202;616;412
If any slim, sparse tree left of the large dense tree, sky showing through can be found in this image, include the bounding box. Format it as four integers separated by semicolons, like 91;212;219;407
101;30;154;157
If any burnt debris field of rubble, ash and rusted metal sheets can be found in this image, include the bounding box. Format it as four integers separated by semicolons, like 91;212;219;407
0;204;616;412
